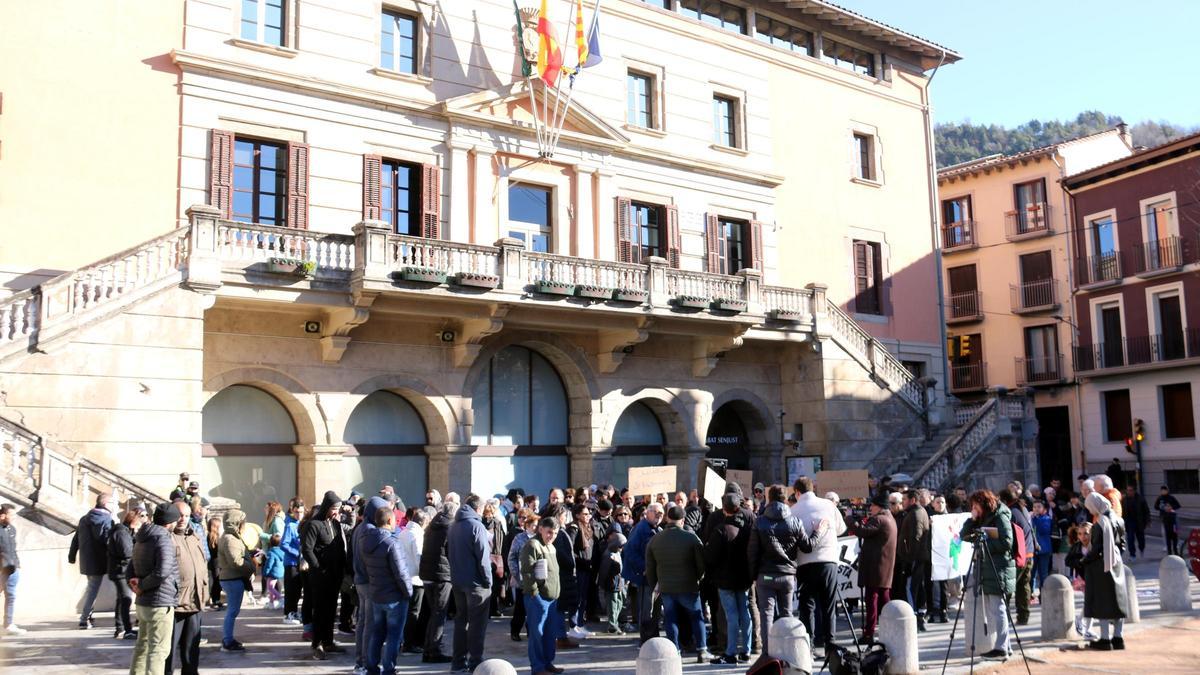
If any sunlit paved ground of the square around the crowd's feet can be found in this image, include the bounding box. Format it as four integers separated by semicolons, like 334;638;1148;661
0;554;1200;675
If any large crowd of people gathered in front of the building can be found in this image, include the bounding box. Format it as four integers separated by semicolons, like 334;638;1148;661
46;461;1178;675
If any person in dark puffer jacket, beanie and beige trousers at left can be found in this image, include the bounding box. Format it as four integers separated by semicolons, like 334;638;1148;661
128;502;179;675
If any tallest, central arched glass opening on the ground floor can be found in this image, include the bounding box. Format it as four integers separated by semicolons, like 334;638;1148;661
470;345;569;496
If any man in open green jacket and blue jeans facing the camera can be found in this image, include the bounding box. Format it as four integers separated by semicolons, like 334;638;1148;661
520;516;566;675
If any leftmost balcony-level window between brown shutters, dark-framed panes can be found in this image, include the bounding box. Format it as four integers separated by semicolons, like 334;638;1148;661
233;138;288;227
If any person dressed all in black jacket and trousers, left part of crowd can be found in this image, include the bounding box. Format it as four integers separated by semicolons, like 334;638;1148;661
300;490;346;659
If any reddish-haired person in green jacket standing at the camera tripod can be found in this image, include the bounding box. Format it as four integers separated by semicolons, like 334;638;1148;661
961;490;1016;661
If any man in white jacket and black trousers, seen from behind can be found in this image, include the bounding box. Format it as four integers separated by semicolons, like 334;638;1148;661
792;476;846;647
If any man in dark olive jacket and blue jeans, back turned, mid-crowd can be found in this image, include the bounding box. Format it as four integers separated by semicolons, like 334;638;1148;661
646;504;713;663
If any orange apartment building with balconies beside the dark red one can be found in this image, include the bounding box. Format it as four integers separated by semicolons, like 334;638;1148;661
937;127;1130;482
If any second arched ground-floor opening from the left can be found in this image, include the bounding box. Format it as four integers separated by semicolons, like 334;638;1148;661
342;390;428;506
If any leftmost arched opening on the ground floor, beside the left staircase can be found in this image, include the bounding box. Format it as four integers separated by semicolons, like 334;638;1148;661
200;384;296;509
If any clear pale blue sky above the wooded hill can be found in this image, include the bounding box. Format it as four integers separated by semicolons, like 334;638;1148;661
833;0;1200;127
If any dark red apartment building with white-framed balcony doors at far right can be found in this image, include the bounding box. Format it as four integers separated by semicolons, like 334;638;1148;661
1063;135;1200;508
